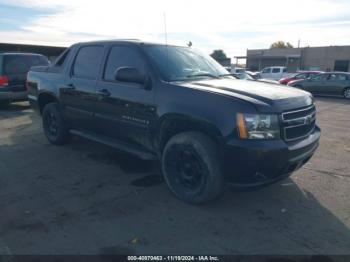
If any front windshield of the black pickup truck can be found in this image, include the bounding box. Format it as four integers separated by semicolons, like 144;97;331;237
145;45;227;81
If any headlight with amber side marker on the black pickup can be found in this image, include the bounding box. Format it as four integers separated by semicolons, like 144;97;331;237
237;113;280;139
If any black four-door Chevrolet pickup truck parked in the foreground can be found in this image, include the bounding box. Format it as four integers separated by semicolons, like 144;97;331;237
27;40;320;204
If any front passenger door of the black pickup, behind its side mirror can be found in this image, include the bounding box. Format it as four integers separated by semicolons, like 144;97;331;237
95;44;156;149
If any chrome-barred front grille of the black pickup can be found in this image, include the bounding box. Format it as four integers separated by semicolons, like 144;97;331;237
282;105;316;141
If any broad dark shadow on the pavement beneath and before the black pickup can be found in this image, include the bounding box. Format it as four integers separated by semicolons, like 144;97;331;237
0;105;350;255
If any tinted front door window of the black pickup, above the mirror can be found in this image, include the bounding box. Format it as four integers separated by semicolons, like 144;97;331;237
103;46;145;81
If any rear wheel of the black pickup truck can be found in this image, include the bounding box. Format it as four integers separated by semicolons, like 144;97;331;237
42;103;70;145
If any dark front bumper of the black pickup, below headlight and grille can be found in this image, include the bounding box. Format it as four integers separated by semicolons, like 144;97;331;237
223;126;321;187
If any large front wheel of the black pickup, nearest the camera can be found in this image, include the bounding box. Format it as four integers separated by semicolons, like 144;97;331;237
162;132;225;204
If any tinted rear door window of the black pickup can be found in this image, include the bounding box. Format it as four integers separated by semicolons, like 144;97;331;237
73;46;103;79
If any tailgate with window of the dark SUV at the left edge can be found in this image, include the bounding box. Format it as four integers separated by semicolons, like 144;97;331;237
3;54;49;92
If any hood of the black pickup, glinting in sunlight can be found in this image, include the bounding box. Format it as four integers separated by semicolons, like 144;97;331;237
180;78;313;113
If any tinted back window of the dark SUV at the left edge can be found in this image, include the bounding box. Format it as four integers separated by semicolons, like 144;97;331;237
3;55;49;75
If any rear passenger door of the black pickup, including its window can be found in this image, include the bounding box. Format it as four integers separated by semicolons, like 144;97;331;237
59;45;104;130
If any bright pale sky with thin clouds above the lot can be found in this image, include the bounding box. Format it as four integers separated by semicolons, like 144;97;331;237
0;0;350;58
